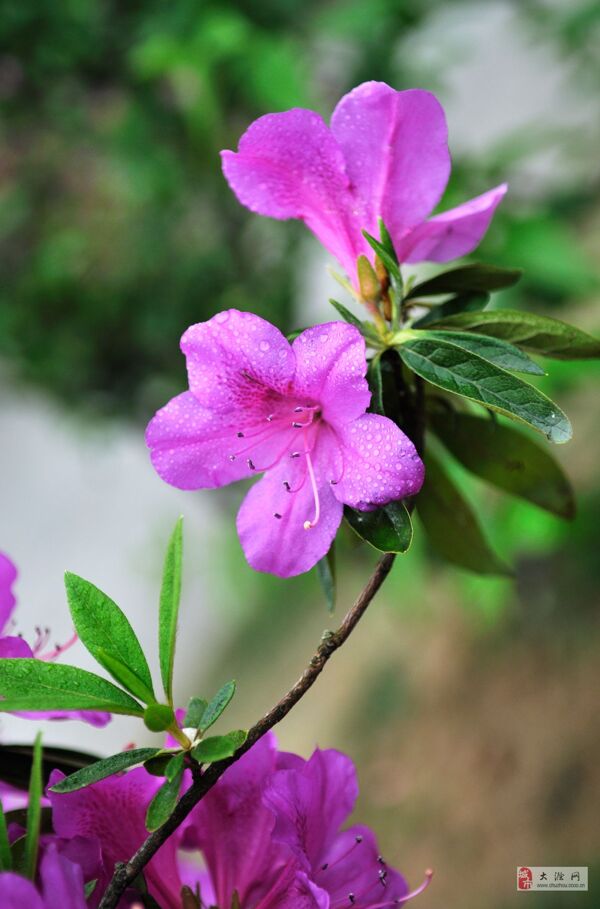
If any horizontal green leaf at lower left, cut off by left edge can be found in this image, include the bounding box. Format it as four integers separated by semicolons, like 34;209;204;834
0;658;144;716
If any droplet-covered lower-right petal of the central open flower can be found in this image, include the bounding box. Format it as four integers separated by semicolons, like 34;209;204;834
333;413;425;509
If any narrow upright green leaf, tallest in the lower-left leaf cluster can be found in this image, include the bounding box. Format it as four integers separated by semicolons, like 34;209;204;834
158;518;183;704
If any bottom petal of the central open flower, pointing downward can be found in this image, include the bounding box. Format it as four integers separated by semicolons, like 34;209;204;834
237;430;343;578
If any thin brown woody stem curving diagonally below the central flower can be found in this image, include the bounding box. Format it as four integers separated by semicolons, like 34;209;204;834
98;552;395;909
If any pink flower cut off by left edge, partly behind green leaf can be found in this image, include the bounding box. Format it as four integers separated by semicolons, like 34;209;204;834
0;552;110;726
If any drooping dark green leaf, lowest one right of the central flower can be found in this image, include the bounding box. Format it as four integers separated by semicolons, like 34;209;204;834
415;452;511;575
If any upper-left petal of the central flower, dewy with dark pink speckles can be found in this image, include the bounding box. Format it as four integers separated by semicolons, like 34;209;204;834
181;309;294;413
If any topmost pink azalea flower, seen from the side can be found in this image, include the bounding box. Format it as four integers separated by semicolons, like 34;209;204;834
221;82;507;281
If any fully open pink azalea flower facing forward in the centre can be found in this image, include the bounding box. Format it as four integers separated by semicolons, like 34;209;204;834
146;310;424;577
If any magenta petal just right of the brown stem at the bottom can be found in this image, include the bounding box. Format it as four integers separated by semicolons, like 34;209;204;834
183;736;285;906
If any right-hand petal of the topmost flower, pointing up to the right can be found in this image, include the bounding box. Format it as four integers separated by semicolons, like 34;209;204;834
397;183;508;262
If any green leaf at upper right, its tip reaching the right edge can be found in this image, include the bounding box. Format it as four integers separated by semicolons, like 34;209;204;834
422;309;600;360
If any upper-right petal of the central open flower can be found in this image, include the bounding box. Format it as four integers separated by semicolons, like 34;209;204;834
292;322;371;425
